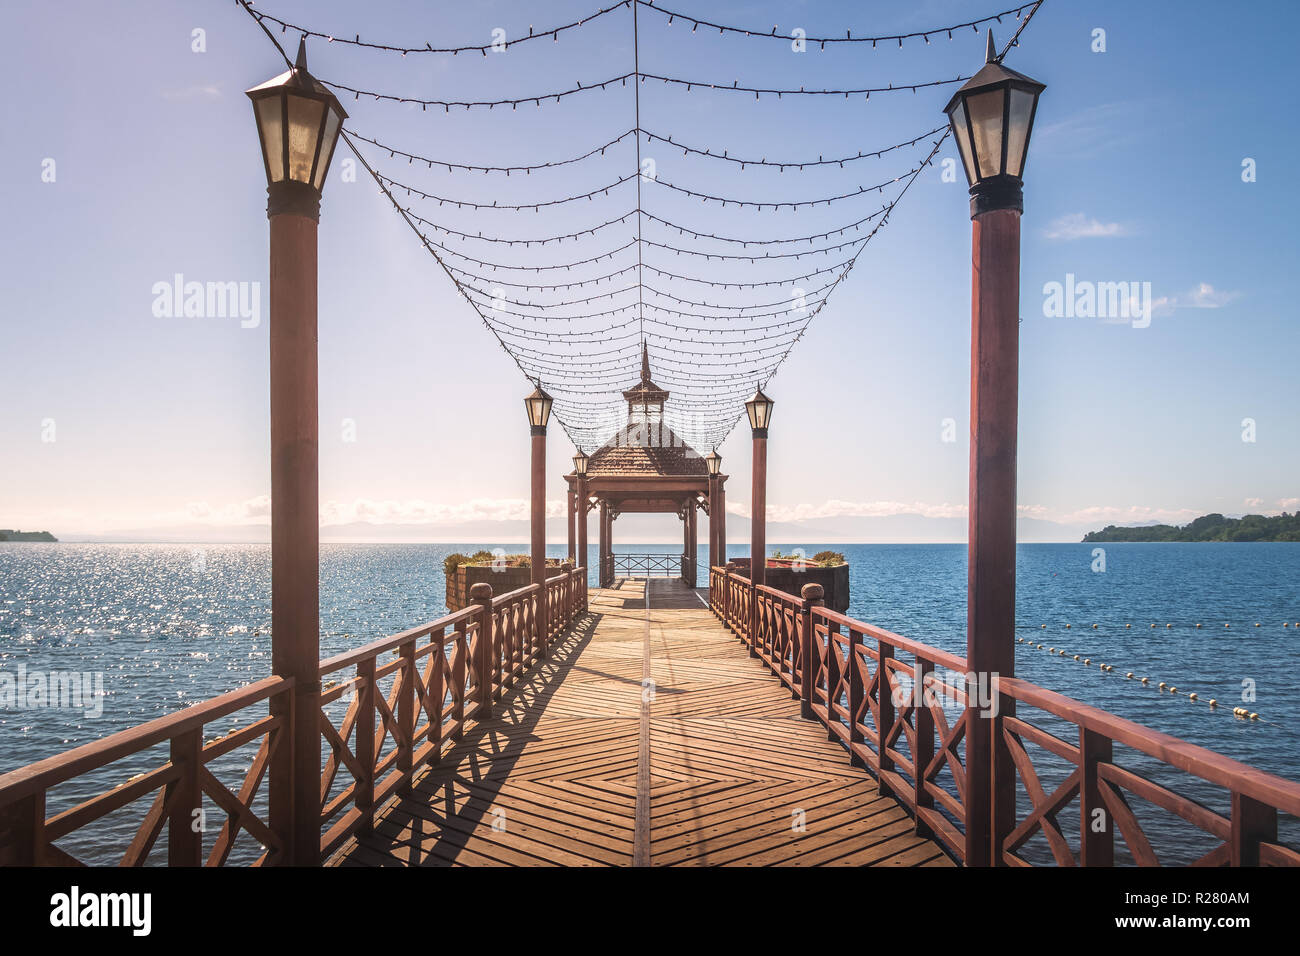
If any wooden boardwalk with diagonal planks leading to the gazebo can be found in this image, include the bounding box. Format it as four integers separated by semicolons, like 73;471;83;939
332;579;953;866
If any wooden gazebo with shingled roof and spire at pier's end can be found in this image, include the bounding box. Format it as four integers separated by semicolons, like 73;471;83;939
564;345;727;588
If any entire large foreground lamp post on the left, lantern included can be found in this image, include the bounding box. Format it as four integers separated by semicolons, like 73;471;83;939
247;40;347;866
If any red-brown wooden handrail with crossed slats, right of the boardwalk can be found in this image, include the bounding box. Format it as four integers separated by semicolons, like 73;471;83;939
709;566;1300;866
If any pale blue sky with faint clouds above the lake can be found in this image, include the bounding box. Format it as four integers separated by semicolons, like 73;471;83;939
0;0;1300;540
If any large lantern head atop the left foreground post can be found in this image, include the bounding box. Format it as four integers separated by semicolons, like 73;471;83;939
247;38;347;219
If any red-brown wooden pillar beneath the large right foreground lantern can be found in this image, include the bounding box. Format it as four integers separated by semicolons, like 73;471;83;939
966;208;1021;866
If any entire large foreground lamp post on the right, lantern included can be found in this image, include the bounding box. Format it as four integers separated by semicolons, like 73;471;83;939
944;31;1045;866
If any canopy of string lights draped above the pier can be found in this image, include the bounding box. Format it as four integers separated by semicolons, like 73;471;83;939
237;0;1041;449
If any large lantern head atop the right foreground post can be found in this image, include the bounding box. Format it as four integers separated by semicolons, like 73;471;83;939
944;31;1047;217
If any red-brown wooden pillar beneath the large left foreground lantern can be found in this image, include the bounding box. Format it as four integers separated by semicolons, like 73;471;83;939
268;196;321;866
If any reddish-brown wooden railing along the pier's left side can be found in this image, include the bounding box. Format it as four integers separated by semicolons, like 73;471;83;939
0;568;586;866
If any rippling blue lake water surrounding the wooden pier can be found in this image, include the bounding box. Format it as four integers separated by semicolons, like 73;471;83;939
0;542;1300;868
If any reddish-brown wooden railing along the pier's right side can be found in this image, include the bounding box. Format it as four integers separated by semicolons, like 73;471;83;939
709;567;1300;866
